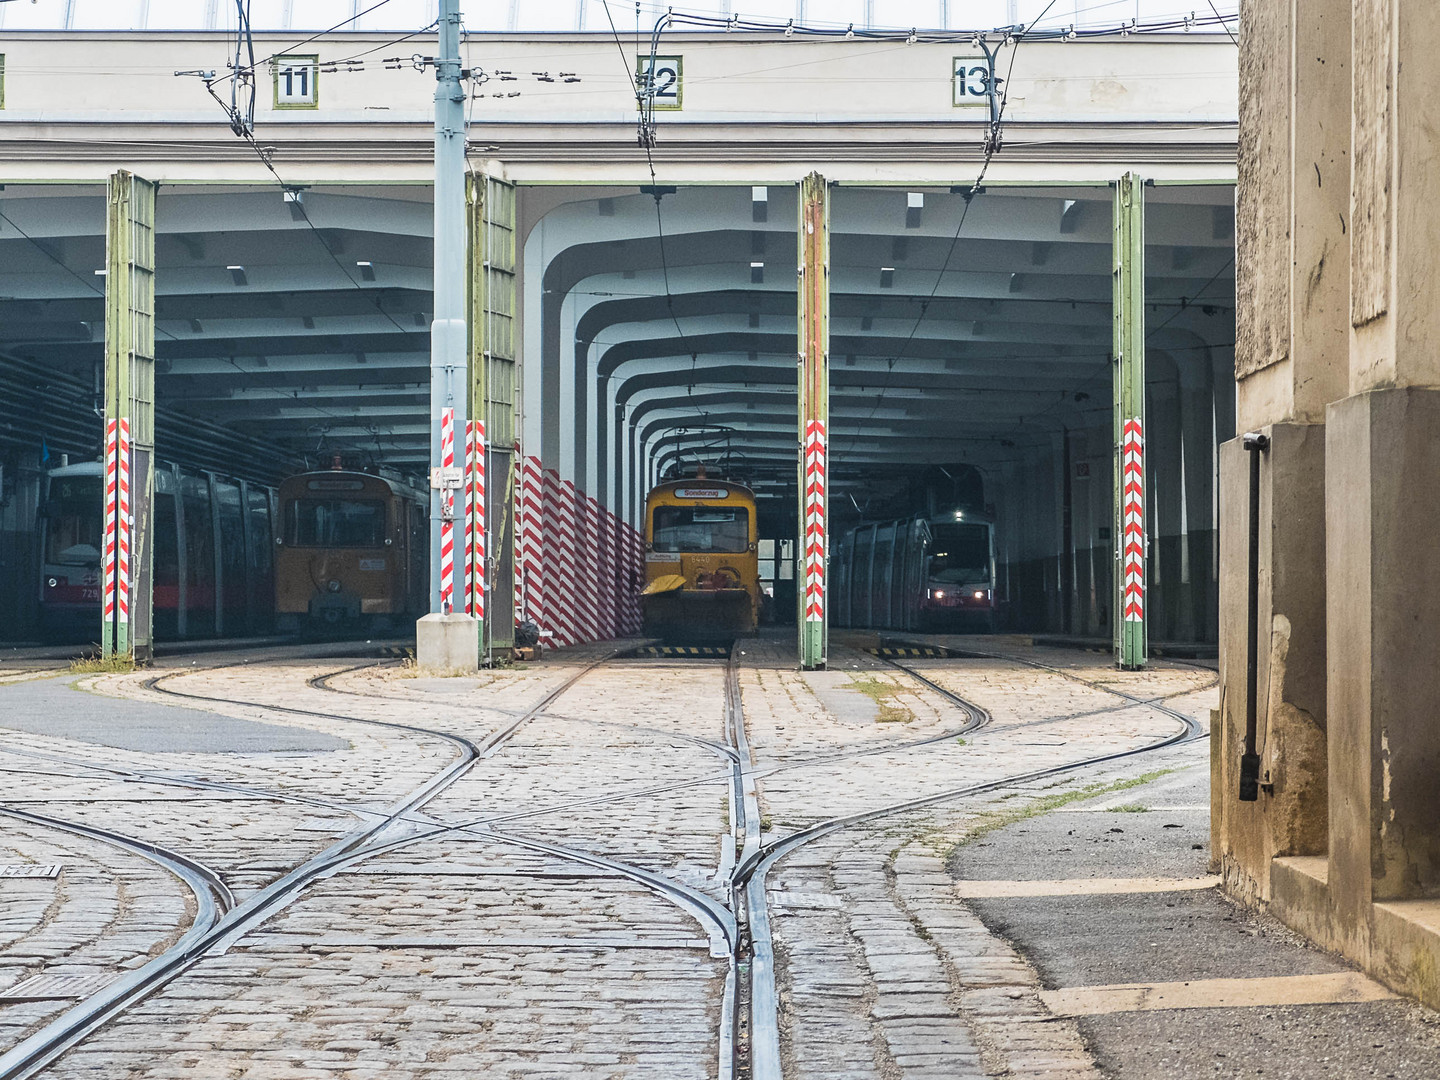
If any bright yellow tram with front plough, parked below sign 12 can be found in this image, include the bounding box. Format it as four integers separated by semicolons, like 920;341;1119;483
641;469;760;642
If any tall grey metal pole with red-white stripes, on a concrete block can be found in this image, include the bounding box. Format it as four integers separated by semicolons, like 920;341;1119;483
431;0;469;612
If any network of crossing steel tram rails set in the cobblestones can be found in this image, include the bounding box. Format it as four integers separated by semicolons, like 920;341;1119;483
0;639;1215;1080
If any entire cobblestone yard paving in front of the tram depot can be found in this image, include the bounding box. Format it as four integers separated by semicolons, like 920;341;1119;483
0;638;1215;1080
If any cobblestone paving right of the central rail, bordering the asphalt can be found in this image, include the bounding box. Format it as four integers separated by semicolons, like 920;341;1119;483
744;642;1215;1080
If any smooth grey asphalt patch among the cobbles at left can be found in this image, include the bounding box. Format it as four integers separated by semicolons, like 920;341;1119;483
0;675;348;753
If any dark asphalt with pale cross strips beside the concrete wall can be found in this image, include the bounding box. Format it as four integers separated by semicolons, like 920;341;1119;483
952;742;1440;1080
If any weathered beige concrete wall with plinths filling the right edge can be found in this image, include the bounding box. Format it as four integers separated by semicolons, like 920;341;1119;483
1212;0;1440;1005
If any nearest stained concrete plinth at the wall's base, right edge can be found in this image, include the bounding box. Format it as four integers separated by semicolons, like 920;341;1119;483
1326;387;1440;923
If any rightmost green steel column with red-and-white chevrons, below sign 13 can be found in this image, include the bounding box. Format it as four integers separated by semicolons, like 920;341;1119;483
1115;173;1149;670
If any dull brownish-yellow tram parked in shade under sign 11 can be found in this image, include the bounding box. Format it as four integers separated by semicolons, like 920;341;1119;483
275;467;429;632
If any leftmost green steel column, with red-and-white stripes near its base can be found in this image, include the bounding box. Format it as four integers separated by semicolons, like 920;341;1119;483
101;171;156;662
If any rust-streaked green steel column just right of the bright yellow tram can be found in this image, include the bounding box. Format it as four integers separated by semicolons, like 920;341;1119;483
796;173;829;668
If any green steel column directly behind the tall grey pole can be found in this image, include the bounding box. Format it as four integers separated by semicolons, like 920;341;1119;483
468;174;518;657
